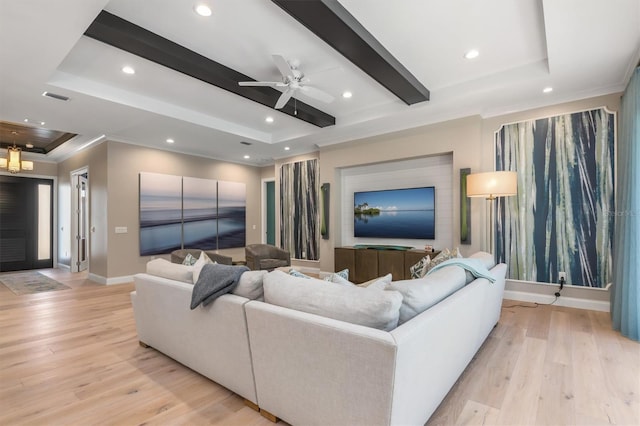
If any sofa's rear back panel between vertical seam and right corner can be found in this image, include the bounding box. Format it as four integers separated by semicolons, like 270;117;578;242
245;301;396;426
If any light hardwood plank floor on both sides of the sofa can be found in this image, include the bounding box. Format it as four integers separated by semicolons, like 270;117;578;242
0;269;640;425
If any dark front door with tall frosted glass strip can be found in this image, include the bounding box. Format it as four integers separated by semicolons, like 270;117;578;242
0;175;54;272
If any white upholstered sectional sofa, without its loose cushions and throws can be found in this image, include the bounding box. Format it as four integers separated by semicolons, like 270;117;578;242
132;251;506;426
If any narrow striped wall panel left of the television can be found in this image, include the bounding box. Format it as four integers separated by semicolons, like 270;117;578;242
280;160;319;260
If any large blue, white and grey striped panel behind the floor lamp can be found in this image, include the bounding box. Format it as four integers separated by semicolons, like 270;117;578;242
496;108;615;287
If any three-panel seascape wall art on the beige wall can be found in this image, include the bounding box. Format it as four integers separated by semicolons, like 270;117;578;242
140;173;246;256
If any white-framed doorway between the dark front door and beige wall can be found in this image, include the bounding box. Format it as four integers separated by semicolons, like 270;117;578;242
71;168;89;272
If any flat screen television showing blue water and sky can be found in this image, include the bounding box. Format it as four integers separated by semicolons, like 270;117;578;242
353;186;436;240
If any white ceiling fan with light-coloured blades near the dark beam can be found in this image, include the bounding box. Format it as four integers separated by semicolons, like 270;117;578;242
238;55;334;109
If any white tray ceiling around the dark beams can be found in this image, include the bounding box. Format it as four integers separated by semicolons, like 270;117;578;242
0;0;640;165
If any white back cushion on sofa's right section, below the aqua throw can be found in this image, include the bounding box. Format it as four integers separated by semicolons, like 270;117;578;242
387;266;466;324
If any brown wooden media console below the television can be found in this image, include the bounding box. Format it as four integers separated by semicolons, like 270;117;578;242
334;245;440;284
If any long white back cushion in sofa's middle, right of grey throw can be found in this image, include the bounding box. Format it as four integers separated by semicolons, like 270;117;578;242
264;271;402;330
